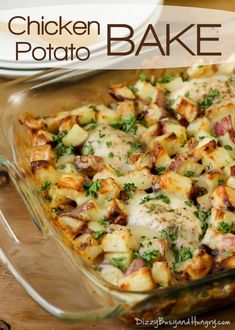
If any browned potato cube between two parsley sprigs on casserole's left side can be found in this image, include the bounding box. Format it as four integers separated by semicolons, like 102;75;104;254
57;173;85;191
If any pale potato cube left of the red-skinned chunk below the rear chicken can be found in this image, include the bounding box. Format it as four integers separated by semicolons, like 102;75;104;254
187;117;212;138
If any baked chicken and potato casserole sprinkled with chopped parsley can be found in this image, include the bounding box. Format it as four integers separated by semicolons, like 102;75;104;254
22;64;235;291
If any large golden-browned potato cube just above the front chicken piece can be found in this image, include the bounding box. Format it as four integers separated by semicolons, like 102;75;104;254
159;171;193;198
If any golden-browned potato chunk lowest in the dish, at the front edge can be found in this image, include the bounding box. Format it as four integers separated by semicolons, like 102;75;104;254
118;267;155;291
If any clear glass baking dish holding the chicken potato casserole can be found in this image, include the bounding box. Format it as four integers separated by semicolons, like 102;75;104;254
0;69;235;324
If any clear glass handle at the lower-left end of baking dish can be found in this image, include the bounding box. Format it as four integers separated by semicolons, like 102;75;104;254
0;156;122;322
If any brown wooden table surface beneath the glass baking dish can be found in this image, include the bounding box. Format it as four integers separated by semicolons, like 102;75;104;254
0;0;235;330
